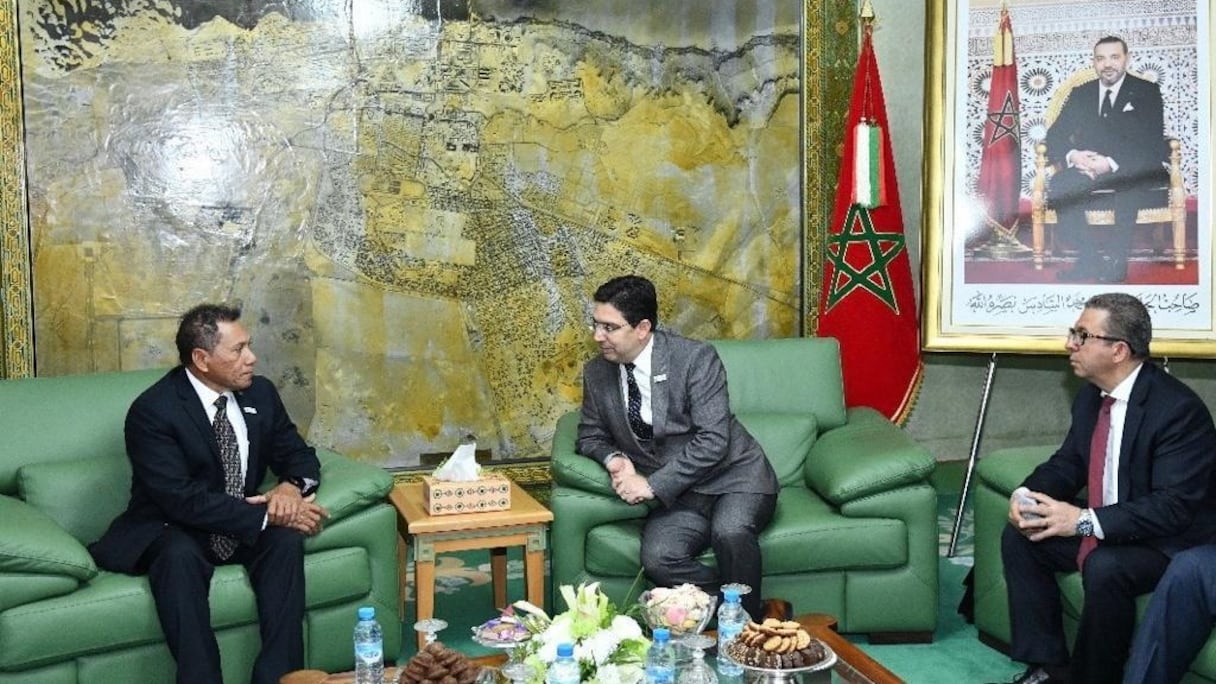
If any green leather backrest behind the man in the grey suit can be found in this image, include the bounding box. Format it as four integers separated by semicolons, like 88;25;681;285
710;337;846;487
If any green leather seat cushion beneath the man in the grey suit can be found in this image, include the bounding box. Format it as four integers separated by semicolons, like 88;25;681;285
586;487;908;577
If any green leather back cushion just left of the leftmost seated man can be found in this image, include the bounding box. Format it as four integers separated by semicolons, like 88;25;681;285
17;456;131;544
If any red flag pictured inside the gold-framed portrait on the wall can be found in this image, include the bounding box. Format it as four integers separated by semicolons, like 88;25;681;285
979;6;1021;237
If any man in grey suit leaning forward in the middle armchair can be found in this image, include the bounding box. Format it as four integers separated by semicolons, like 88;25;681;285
578;275;777;618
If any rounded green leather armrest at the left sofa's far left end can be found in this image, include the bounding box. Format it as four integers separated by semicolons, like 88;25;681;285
0;495;97;576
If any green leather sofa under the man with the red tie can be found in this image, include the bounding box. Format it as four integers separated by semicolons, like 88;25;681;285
972;445;1216;682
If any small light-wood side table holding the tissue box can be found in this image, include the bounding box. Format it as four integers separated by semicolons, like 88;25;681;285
389;482;553;649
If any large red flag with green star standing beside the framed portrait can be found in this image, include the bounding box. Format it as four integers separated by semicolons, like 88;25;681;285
818;22;922;422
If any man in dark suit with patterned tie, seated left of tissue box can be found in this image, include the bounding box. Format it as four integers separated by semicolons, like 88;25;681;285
90;304;328;684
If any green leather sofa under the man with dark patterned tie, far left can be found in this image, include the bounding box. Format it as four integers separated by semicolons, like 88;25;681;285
0;370;401;684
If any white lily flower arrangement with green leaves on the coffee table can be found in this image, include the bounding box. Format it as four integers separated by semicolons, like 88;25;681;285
514;582;651;684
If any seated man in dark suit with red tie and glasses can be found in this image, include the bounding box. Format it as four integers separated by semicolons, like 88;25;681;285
1001;292;1216;684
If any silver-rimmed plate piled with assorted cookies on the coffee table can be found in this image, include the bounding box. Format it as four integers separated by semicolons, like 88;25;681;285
726;617;837;674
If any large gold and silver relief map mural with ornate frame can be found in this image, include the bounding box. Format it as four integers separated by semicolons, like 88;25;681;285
0;0;856;467
